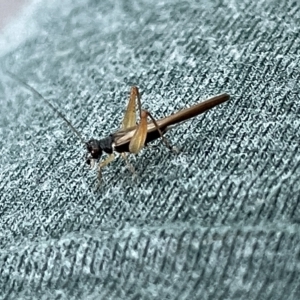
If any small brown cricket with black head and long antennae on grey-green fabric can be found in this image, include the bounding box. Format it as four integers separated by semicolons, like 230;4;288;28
6;71;230;180
